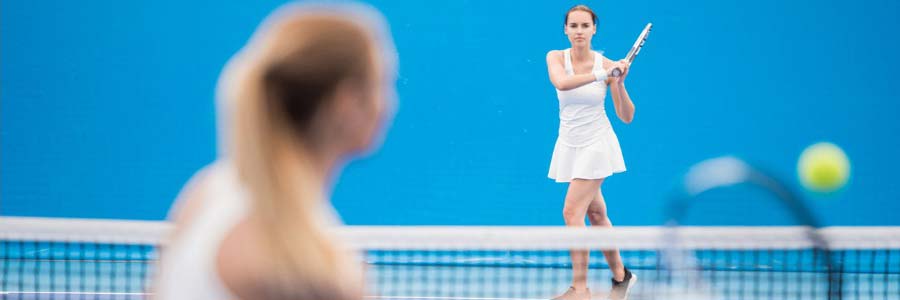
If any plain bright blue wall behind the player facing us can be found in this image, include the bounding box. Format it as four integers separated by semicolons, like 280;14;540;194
0;0;900;225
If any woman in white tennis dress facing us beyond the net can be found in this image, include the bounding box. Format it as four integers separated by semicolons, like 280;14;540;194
547;5;637;299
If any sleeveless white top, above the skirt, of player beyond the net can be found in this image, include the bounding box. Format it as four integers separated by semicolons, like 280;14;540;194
556;49;612;147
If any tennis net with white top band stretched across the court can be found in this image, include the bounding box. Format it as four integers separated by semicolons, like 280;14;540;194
0;218;900;299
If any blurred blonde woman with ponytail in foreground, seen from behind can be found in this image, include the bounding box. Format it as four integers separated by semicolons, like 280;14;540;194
154;4;396;299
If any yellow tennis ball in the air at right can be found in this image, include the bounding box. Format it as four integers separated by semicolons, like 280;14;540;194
797;142;850;193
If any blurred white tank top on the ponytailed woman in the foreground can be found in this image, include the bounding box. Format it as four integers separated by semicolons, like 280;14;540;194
154;160;248;300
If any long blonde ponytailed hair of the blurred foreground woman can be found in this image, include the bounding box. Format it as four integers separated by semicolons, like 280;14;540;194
219;4;393;299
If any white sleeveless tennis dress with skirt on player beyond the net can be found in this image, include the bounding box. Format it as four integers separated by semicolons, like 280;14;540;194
547;49;625;182
